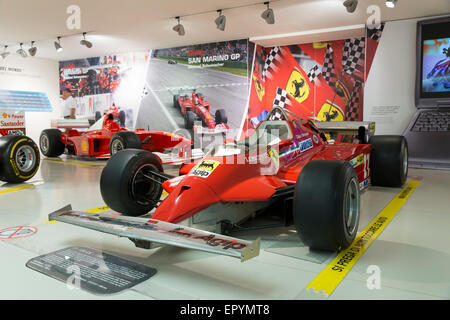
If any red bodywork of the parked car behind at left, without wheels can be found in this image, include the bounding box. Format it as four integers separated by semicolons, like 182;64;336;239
61;107;193;157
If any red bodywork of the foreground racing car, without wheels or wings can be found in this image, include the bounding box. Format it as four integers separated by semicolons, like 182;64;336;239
152;115;371;223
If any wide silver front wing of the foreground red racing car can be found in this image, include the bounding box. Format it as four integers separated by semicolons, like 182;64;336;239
48;205;260;262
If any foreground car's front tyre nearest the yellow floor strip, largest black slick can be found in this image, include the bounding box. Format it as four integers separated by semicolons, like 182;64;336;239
293;160;360;251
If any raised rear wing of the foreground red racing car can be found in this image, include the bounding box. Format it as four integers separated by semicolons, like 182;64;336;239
314;121;375;143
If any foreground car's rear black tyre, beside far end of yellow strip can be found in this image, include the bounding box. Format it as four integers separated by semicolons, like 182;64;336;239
369;136;408;188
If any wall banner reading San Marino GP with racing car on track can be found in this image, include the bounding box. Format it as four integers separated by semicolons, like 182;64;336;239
137;39;254;149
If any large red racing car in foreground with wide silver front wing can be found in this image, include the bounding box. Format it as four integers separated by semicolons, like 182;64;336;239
50;107;408;260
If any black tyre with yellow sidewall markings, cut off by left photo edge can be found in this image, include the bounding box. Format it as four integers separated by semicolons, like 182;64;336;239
0;135;41;183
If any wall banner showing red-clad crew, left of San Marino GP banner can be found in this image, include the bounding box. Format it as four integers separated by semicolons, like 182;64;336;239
59;52;149;129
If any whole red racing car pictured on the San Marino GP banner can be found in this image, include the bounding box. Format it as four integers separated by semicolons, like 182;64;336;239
173;89;229;134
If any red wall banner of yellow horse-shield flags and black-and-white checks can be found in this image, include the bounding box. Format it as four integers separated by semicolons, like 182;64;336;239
242;25;384;137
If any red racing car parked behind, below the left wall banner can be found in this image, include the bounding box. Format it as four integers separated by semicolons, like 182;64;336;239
39;107;202;163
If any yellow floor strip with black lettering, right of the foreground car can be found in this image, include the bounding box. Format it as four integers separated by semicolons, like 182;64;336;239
306;180;420;296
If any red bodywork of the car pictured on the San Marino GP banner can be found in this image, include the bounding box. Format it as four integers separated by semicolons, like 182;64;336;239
178;90;229;130
